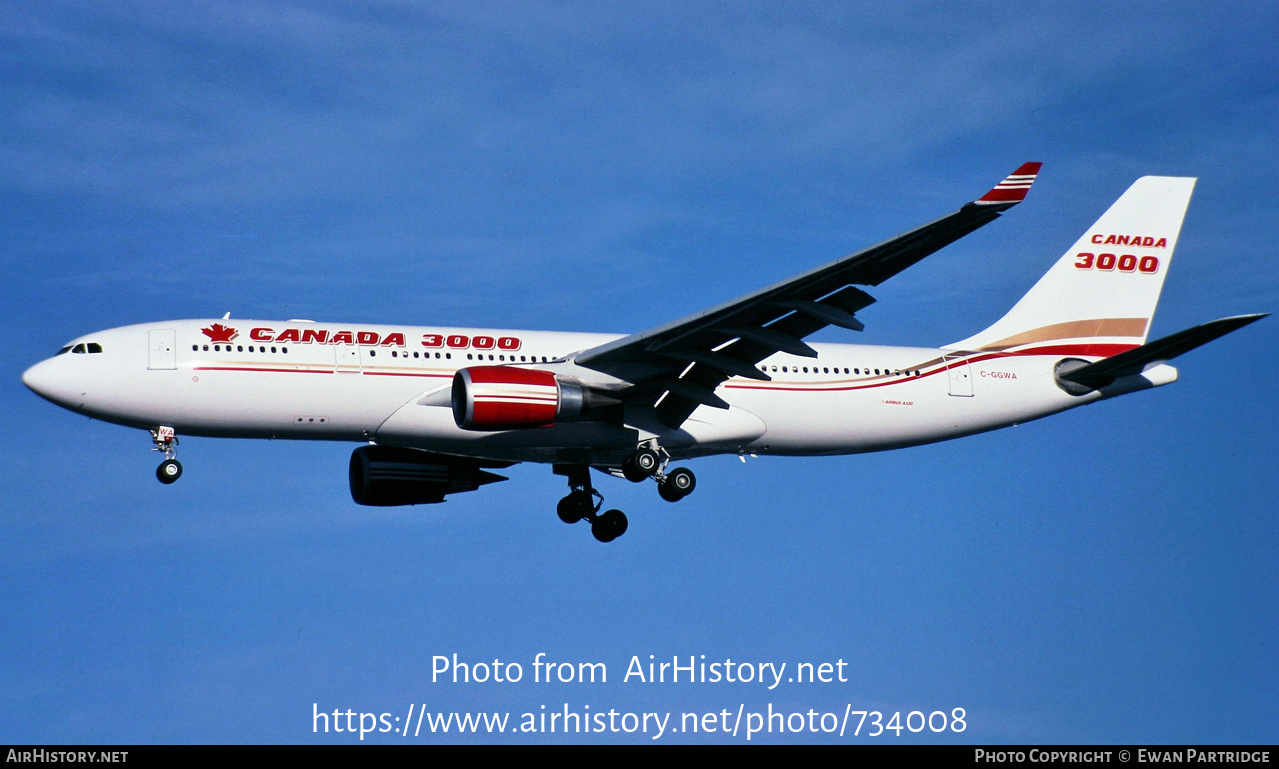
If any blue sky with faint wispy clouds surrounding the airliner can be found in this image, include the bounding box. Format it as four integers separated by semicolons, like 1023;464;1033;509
0;1;1279;743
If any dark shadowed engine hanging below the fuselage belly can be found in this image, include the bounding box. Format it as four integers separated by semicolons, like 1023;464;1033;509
350;445;509;507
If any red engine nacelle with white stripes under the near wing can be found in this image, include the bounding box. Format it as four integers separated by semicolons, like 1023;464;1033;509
453;366;591;430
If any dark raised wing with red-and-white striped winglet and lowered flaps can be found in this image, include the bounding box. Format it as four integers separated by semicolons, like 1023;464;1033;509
576;163;1041;427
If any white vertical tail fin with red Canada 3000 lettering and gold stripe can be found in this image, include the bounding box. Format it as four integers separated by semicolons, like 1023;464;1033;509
945;177;1196;357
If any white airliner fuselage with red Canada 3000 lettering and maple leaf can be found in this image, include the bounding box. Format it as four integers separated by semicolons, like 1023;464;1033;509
23;320;1164;463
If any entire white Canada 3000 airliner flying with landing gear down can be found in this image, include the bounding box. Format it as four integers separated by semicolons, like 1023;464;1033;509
23;163;1266;543
